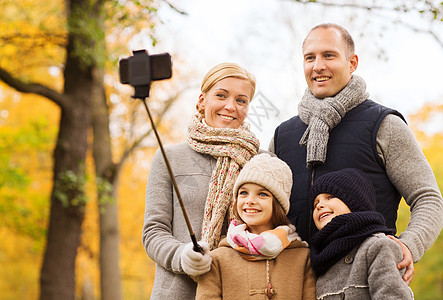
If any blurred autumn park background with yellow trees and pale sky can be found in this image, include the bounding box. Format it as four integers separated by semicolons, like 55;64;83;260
0;0;443;300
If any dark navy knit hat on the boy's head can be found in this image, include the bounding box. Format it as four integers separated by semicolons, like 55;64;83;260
309;168;376;212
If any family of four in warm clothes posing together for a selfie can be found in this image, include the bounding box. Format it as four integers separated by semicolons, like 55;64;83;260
142;24;443;300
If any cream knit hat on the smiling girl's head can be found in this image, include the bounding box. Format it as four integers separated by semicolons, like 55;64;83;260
233;153;292;214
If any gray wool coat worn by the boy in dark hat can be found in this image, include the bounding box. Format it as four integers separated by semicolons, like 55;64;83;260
316;233;414;300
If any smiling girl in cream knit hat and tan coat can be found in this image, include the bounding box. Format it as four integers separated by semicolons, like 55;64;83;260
196;154;315;299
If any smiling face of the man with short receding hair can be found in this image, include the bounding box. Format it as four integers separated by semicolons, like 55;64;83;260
303;28;358;99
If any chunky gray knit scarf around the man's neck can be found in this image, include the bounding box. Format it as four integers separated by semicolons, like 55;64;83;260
298;75;369;167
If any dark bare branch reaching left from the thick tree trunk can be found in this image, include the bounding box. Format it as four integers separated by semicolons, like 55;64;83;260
0;67;67;107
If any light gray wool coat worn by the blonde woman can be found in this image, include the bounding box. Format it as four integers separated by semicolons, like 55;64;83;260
142;143;216;300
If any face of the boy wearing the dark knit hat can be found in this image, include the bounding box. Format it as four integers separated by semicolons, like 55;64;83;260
313;193;351;230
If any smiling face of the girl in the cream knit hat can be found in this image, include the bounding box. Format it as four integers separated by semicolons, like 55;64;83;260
237;183;274;234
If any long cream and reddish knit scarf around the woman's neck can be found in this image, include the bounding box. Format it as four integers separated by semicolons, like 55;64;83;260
188;114;260;249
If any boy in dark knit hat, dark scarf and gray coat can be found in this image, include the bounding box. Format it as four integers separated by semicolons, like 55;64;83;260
309;168;414;300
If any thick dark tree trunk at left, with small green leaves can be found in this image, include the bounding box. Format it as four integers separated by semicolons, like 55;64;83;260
40;0;92;300
